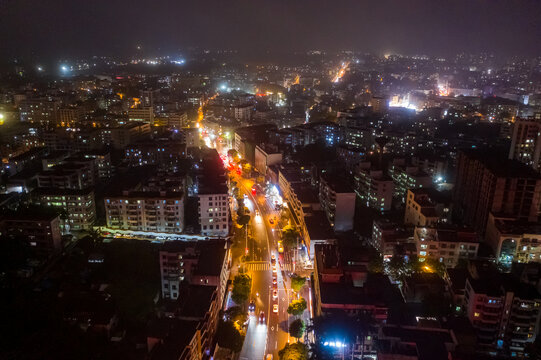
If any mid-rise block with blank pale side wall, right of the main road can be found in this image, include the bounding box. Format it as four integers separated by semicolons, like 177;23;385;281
319;175;355;231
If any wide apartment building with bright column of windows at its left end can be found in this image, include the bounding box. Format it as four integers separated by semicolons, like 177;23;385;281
413;226;480;268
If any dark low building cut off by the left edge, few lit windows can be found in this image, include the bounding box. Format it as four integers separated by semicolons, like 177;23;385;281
0;208;62;256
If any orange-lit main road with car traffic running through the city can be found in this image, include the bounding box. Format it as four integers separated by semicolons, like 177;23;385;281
235;176;292;360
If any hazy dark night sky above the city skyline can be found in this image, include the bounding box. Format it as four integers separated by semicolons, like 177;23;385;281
0;0;541;58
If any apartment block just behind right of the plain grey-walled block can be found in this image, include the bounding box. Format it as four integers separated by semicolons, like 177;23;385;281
354;163;394;212
